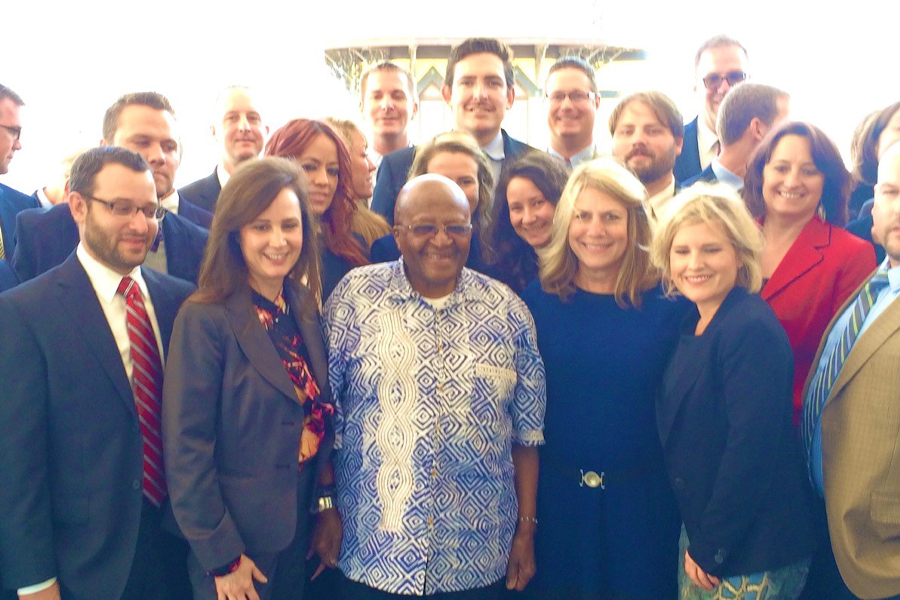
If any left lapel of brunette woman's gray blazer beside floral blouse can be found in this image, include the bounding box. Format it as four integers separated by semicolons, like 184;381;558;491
225;288;299;402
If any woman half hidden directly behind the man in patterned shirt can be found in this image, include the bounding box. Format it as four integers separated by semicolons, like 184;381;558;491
372;131;494;272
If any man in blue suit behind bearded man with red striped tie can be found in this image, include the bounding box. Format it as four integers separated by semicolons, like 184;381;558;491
12;92;212;283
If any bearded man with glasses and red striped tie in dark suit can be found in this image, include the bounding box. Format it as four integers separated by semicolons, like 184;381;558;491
0;148;193;600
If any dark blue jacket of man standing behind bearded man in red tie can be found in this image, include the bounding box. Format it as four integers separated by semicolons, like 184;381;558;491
12;204;209;284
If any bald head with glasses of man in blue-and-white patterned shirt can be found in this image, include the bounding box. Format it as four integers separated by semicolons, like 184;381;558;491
394;174;472;298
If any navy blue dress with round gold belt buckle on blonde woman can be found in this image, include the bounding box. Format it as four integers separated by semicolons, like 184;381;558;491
523;280;689;600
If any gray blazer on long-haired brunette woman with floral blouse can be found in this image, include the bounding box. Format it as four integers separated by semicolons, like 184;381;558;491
162;285;334;570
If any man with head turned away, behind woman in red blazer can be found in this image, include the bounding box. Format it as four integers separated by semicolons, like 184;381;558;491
679;82;791;191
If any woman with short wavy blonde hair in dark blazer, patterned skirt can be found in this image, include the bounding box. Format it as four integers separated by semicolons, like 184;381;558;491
652;183;813;600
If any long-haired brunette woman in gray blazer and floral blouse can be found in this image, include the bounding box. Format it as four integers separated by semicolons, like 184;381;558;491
162;158;333;600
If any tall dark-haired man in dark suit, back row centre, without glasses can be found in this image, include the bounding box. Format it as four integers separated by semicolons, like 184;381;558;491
372;38;530;224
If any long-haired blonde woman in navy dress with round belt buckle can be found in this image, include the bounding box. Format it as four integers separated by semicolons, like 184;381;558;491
522;158;684;600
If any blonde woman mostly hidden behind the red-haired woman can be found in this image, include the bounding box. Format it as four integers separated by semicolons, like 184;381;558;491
325;117;391;247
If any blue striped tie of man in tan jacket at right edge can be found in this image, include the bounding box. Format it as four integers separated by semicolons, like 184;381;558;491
801;270;888;456
